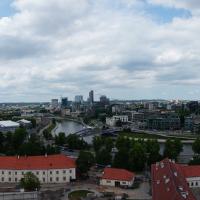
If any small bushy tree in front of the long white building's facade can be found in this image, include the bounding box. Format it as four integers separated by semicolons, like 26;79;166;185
20;172;40;191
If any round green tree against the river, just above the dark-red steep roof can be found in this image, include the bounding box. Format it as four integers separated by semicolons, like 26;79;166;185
164;139;183;160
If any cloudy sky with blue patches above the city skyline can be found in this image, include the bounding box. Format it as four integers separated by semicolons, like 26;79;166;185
0;0;200;102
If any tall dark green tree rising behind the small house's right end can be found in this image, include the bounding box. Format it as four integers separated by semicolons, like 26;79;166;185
129;142;146;171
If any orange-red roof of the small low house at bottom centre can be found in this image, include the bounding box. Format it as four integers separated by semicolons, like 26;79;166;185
102;168;135;181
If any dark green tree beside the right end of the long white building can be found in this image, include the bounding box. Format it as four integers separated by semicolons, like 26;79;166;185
76;151;95;175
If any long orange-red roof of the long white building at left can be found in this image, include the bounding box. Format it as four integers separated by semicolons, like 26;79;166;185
0;154;75;170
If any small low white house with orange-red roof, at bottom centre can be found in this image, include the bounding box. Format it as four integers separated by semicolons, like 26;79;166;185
100;168;135;187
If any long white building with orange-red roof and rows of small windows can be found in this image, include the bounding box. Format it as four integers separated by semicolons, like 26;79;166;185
0;155;76;184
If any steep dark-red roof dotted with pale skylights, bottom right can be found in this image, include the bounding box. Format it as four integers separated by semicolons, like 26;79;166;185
151;159;196;200
